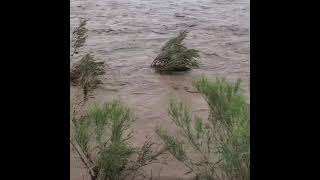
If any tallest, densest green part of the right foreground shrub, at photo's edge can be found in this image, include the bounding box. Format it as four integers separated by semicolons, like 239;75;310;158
194;77;250;179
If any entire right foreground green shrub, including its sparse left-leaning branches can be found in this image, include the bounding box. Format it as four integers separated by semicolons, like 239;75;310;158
158;77;250;180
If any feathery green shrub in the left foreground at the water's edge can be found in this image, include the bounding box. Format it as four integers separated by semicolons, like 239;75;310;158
74;101;136;180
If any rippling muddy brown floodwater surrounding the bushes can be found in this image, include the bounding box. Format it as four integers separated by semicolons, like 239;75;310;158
70;0;250;180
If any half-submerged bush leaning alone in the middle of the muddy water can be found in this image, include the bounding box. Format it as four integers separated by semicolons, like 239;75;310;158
151;31;199;71
